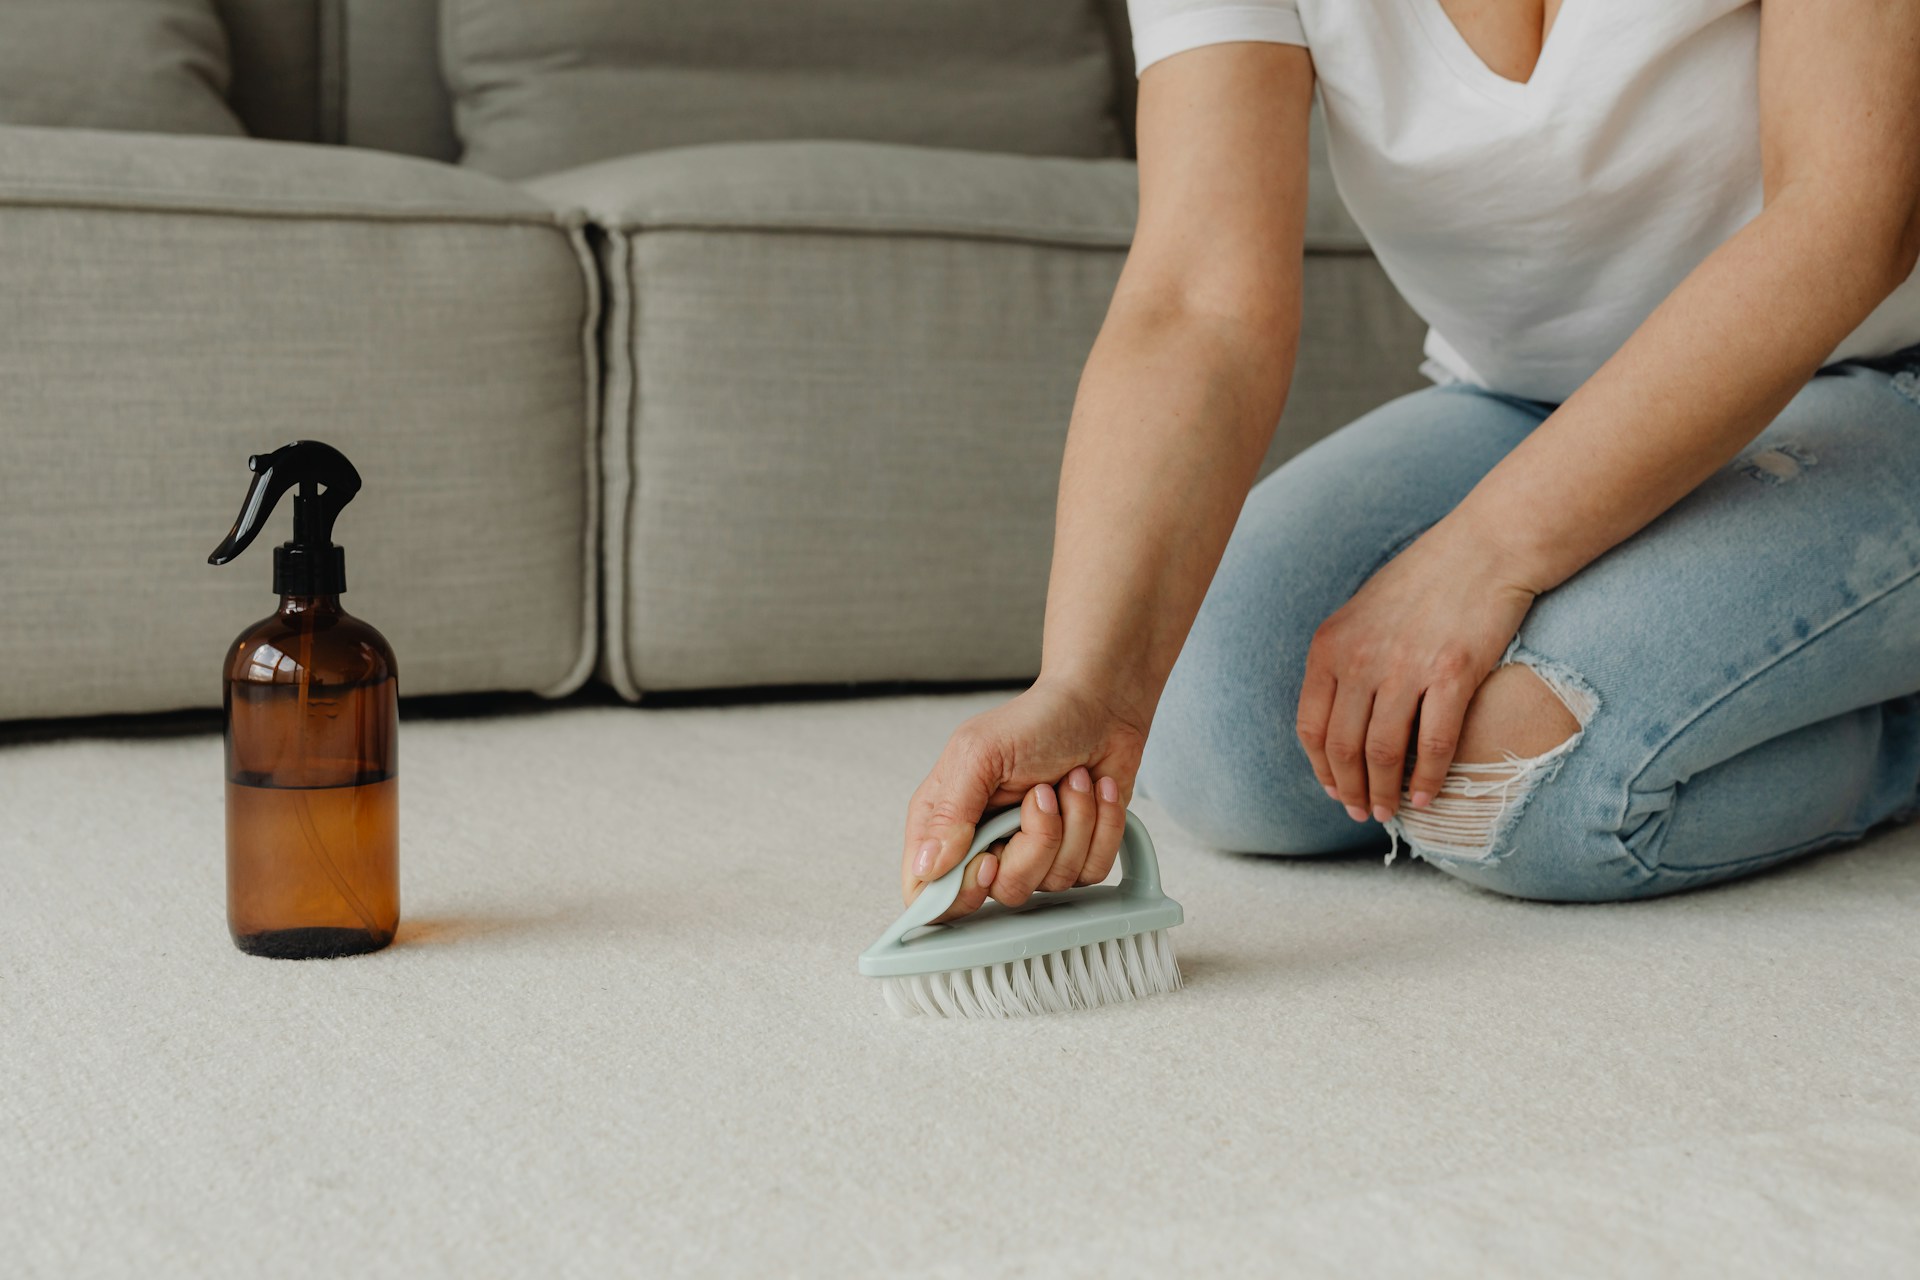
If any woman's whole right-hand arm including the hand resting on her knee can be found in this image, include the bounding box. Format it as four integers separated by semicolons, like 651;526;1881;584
1300;0;1920;814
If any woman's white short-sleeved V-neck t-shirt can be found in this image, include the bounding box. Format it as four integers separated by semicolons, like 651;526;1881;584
1129;0;1920;401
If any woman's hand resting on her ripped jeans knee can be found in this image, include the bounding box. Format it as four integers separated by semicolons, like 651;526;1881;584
1296;520;1536;821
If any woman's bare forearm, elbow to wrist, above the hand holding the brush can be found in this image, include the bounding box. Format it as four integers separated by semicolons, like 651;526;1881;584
1043;301;1298;723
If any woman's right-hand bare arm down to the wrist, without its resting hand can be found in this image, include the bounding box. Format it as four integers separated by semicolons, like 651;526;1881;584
1455;0;1920;591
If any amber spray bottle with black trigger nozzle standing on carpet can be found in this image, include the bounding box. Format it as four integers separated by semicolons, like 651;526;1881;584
207;439;399;960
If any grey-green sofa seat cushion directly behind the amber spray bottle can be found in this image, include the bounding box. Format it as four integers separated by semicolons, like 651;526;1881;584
0;129;597;720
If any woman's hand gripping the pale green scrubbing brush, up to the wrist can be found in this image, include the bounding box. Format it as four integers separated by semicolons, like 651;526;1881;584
900;677;1146;919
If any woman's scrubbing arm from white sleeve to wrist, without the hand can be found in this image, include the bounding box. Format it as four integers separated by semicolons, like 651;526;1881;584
1041;44;1313;729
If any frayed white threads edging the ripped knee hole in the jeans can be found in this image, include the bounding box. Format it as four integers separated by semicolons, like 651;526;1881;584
1386;651;1599;864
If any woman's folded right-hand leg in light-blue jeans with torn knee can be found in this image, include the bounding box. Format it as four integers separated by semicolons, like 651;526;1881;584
1402;365;1920;900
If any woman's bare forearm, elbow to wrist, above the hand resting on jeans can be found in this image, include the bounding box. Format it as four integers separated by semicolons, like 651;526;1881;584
1448;192;1901;591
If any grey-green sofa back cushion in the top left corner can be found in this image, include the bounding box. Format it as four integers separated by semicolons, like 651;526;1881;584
0;0;246;134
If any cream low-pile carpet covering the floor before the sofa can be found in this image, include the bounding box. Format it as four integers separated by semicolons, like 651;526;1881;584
0;695;1920;1276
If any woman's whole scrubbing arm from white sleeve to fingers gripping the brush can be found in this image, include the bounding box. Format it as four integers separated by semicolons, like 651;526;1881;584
900;42;1313;915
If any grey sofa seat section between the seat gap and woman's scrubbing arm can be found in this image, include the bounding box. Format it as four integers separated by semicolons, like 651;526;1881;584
534;142;1135;697
